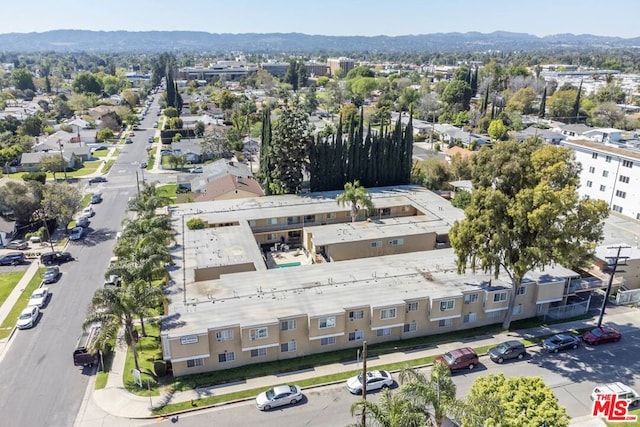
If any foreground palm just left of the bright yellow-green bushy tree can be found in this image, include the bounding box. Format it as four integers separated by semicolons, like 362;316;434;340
400;363;461;427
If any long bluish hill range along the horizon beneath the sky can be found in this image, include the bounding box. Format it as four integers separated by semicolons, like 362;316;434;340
0;30;640;53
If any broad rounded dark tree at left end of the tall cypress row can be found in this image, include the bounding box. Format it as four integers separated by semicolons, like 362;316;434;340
271;100;311;194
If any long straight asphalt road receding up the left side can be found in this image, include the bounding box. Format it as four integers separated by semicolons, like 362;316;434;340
0;96;157;427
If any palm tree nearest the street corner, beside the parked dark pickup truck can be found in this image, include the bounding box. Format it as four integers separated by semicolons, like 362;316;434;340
83;288;141;370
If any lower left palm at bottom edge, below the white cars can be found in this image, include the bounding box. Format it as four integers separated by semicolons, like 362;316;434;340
351;388;425;427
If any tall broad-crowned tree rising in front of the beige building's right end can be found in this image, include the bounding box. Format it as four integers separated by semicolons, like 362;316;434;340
449;139;609;329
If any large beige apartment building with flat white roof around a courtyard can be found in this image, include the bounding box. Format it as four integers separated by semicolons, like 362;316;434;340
161;186;602;376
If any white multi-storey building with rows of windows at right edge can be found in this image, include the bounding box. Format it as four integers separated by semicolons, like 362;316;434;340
561;140;640;220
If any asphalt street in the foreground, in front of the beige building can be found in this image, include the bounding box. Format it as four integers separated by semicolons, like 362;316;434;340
141;330;640;427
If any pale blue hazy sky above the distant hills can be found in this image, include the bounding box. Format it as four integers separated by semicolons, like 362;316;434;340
5;0;640;38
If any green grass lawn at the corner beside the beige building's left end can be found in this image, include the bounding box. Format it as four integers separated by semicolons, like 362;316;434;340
122;322;162;396
